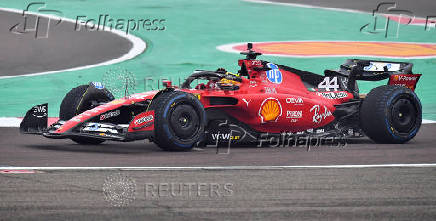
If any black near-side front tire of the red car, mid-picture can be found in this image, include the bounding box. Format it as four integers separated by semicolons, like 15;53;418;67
150;91;206;151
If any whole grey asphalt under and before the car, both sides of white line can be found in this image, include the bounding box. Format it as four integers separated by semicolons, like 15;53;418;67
0;124;436;220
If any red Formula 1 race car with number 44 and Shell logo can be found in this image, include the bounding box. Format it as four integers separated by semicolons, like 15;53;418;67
20;43;422;150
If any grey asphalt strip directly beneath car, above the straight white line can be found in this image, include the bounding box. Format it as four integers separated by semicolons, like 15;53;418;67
0;124;436;167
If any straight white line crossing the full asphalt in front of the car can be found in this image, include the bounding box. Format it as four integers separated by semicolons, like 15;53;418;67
0;163;436;171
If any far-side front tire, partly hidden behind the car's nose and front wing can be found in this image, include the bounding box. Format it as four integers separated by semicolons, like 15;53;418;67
59;85;113;145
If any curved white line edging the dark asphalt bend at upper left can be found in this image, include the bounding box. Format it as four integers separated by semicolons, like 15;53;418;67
0;8;147;79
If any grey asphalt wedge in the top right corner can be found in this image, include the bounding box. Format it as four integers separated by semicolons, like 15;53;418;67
267;0;436;18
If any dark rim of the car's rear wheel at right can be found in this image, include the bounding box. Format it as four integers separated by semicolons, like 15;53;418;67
391;98;417;133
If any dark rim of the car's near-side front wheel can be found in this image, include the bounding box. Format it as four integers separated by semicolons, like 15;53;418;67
169;104;200;141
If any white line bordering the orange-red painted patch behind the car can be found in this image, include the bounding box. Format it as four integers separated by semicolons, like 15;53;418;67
216;40;436;59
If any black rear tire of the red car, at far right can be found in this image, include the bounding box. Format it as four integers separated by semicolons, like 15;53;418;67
360;85;422;144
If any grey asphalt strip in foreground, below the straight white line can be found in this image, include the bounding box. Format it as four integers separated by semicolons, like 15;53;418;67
0;167;436;221
